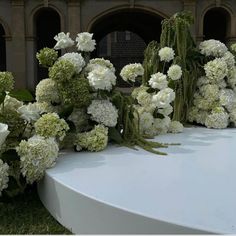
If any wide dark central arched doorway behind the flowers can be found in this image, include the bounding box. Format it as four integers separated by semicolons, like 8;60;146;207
90;9;163;87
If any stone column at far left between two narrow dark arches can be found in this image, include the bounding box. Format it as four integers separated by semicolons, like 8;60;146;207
8;0;27;88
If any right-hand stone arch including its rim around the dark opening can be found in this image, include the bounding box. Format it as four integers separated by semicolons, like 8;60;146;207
200;4;233;43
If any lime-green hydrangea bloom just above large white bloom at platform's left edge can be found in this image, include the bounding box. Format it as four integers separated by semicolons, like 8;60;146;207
34;113;69;141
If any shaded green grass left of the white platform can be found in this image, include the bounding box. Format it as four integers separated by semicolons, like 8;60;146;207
0;187;72;234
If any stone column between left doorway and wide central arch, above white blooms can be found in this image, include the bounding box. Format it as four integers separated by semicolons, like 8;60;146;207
68;0;81;39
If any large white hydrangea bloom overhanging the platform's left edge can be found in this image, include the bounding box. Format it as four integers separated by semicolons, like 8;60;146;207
16;135;59;184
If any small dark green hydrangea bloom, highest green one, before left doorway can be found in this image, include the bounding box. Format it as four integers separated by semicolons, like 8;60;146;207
36;47;58;67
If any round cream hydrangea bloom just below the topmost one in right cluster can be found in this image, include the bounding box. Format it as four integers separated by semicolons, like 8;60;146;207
204;58;228;83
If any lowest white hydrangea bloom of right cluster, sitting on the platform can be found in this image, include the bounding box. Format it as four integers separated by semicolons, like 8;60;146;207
205;107;229;129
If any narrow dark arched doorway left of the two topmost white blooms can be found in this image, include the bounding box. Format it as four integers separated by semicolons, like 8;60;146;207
35;8;61;82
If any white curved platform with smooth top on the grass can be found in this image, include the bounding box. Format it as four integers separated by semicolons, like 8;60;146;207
38;128;236;234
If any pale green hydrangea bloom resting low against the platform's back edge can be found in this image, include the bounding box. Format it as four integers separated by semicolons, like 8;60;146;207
74;125;108;152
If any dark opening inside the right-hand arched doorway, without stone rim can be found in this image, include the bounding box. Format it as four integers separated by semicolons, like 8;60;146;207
203;7;231;43
